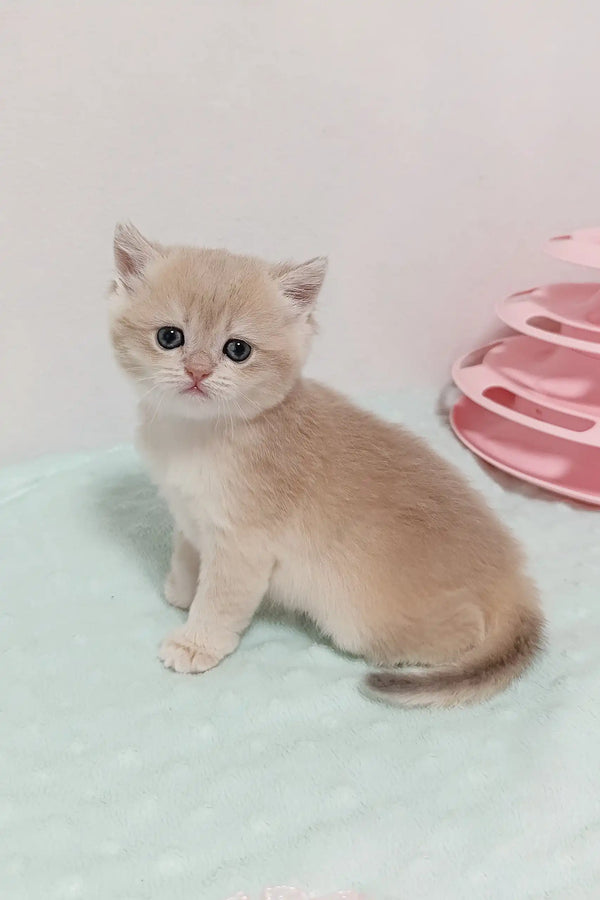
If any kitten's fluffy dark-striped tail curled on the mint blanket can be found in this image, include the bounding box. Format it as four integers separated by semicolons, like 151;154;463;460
366;610;544;707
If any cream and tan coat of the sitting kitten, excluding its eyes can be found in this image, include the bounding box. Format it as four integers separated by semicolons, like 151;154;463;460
111;225;543;706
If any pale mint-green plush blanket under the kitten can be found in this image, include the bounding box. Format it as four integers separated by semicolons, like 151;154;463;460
0;394;600;900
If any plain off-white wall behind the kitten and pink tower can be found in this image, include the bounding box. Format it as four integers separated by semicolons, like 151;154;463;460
0;0;600;460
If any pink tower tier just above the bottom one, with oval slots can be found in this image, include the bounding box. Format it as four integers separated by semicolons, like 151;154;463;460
452;336;600;448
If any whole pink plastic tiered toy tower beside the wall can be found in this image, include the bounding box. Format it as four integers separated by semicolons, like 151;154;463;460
452;228;600;506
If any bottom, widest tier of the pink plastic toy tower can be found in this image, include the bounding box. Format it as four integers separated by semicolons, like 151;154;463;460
451;397;600;506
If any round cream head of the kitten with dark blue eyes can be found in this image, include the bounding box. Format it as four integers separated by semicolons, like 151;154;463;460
105;225;327;418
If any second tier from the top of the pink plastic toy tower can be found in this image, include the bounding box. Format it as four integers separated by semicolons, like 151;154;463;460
496;283;600;356
